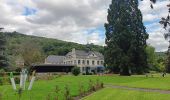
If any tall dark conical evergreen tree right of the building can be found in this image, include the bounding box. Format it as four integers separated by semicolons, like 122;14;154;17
105;0;148;75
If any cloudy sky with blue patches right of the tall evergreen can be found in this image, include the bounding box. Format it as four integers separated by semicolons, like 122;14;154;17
139;0;169;51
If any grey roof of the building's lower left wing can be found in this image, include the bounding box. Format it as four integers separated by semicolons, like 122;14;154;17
46;55;64;64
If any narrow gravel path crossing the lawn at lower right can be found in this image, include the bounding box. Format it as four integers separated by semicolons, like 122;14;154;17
104;84;170;94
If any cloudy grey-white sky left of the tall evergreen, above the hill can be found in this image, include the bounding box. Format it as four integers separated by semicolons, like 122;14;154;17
0;0;110;45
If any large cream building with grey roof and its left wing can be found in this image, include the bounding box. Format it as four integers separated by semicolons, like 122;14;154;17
45;49;104;73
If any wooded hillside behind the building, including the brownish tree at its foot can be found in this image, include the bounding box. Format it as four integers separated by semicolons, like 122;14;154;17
0;32;104;70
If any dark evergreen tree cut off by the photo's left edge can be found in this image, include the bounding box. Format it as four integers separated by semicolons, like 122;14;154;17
0;28;8;69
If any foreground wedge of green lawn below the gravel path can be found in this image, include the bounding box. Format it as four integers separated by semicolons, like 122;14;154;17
83;88;170;100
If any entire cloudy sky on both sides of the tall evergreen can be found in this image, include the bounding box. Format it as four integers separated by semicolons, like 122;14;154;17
0;0;169;51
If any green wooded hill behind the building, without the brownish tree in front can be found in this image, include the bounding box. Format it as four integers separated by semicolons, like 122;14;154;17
4;32;104;66
